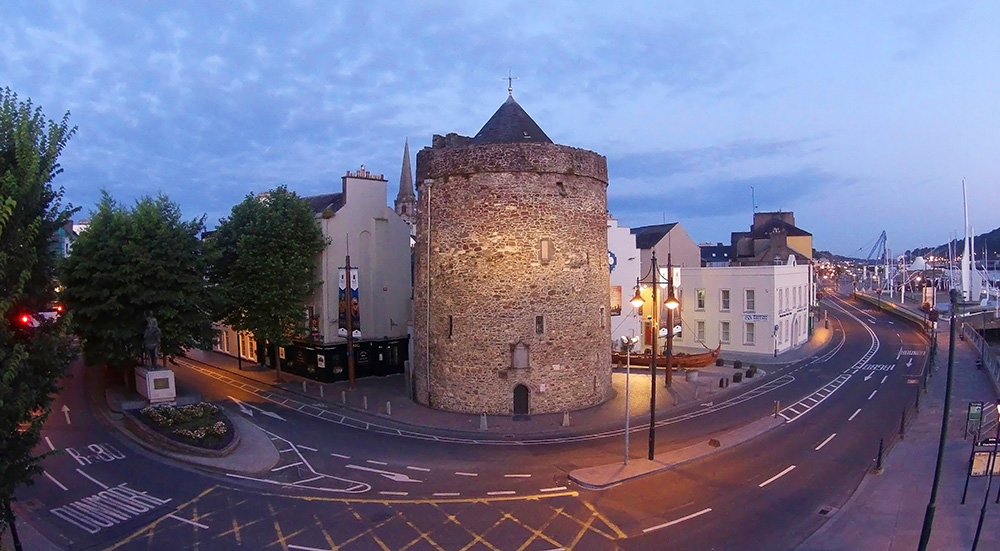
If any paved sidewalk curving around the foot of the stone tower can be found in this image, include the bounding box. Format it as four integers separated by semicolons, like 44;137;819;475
187;328;839;441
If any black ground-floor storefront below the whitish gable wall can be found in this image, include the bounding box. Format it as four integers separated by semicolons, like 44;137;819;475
269;337;409;383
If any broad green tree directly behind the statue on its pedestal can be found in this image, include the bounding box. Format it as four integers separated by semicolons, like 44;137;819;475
62;191;215;381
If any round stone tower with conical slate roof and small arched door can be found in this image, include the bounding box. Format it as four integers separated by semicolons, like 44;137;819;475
411;96;611;415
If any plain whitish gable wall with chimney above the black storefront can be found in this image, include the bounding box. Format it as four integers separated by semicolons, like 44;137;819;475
307;166;413;343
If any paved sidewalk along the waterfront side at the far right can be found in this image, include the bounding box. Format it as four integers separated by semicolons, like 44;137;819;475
798;292;1000;551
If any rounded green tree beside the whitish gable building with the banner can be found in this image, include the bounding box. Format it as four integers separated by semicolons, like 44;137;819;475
213;186;327;377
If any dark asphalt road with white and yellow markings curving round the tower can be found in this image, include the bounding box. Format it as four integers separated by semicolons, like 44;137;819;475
11;292;925;551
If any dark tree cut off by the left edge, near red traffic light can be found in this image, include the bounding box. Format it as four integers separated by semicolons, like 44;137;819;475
0;88;76;549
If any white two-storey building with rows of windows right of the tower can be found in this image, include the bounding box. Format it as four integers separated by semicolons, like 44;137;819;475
674;257;814;355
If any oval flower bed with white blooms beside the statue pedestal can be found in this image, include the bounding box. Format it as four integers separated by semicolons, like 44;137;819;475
136;402;235;450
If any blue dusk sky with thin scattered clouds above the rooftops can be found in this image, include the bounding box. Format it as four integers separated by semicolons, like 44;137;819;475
0;0;1000;256
